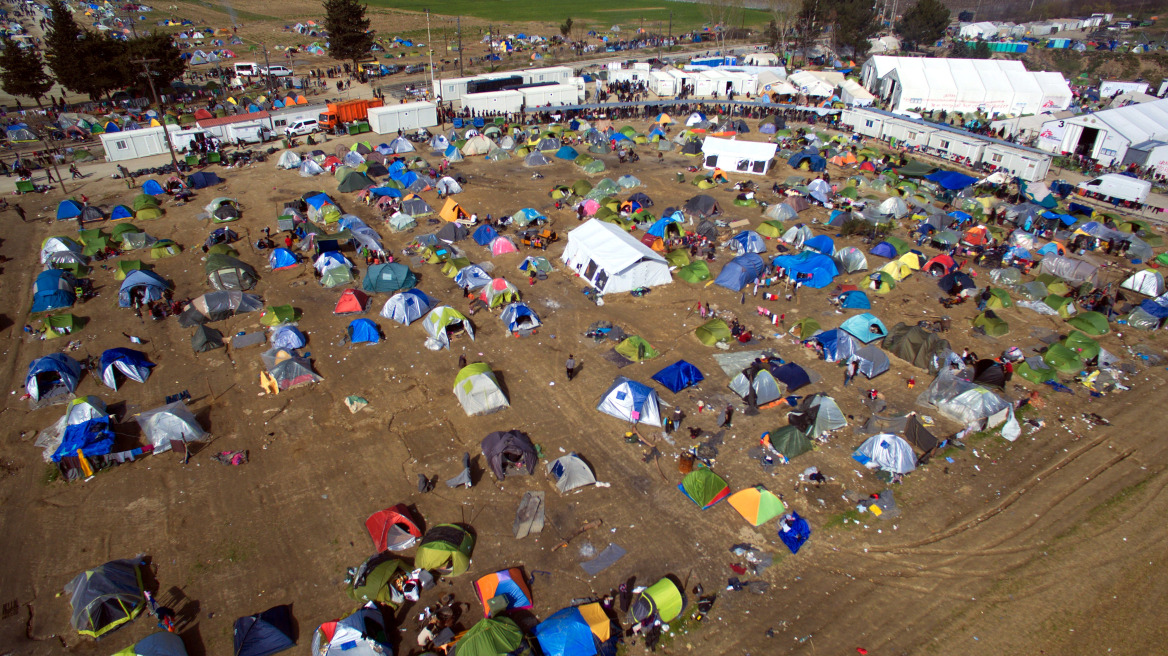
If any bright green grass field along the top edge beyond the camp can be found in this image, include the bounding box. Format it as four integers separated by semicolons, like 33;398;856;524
369;0;770;30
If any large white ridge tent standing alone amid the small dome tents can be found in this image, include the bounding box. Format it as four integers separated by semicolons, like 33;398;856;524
561;218;673;293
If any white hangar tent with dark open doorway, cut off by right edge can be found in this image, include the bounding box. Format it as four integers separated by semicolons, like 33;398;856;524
1038;99;1168;173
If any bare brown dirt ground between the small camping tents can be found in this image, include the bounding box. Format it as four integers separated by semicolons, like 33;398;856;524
0;108;1168;656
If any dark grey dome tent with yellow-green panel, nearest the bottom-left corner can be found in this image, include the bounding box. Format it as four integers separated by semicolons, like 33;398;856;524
65;559;146;637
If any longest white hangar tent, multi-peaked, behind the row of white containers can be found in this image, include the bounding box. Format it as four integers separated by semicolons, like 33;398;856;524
860;55;1071;116
